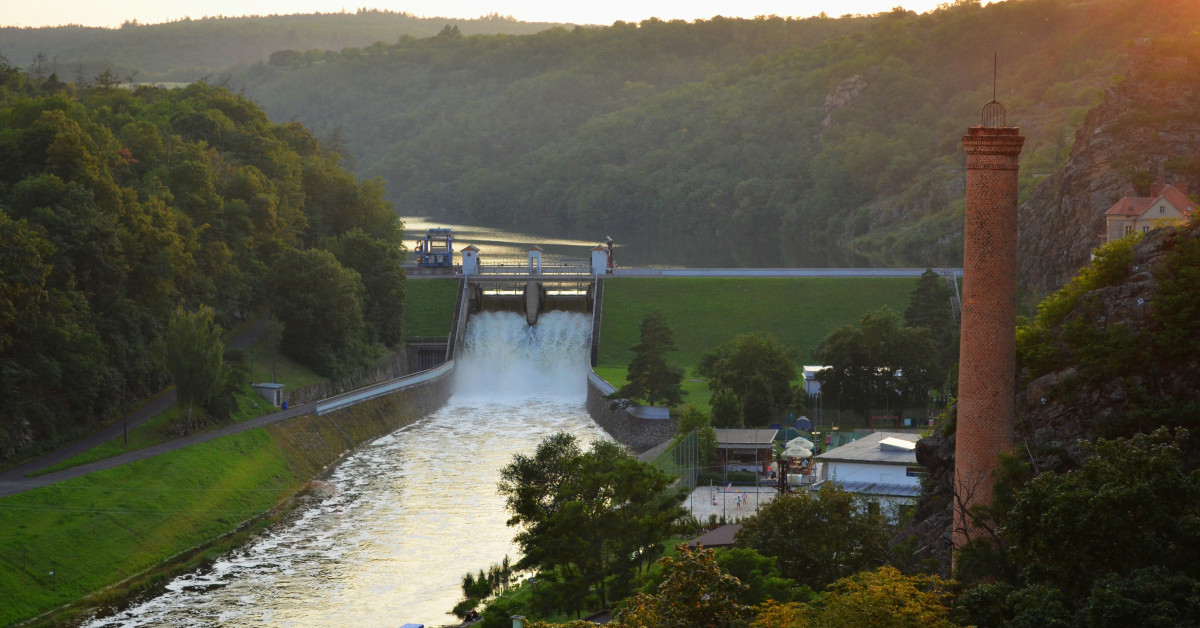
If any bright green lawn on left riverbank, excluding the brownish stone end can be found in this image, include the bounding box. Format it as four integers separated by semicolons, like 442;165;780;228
0;430;299;626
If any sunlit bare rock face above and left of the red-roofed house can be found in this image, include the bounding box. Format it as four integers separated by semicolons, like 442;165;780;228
1018;55;1200;298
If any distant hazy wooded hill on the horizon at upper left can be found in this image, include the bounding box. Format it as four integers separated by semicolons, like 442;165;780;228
0;10;566;86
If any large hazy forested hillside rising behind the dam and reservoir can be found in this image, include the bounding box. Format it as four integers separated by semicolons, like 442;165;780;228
234;0;1200;265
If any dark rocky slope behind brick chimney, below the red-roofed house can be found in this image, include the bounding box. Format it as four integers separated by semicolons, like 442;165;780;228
908;187;1200;573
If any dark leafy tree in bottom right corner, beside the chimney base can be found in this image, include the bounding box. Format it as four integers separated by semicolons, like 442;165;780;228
956;429;1200;626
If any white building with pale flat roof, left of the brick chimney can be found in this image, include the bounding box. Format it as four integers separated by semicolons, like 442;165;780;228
814;432;925;510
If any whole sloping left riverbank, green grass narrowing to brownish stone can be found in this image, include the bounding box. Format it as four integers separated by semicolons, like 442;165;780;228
0;377;450;626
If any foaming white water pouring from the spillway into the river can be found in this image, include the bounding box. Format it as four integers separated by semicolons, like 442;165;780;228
88;312;602;628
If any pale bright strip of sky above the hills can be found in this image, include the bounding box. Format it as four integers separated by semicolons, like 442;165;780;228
0;0;944;26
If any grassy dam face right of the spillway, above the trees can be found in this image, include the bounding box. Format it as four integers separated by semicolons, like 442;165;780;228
596;277;917;407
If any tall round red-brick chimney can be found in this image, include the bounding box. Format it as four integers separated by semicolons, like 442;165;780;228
954;100;1025;549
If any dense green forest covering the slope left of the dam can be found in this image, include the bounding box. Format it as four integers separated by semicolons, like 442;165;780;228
0;66;403;462
